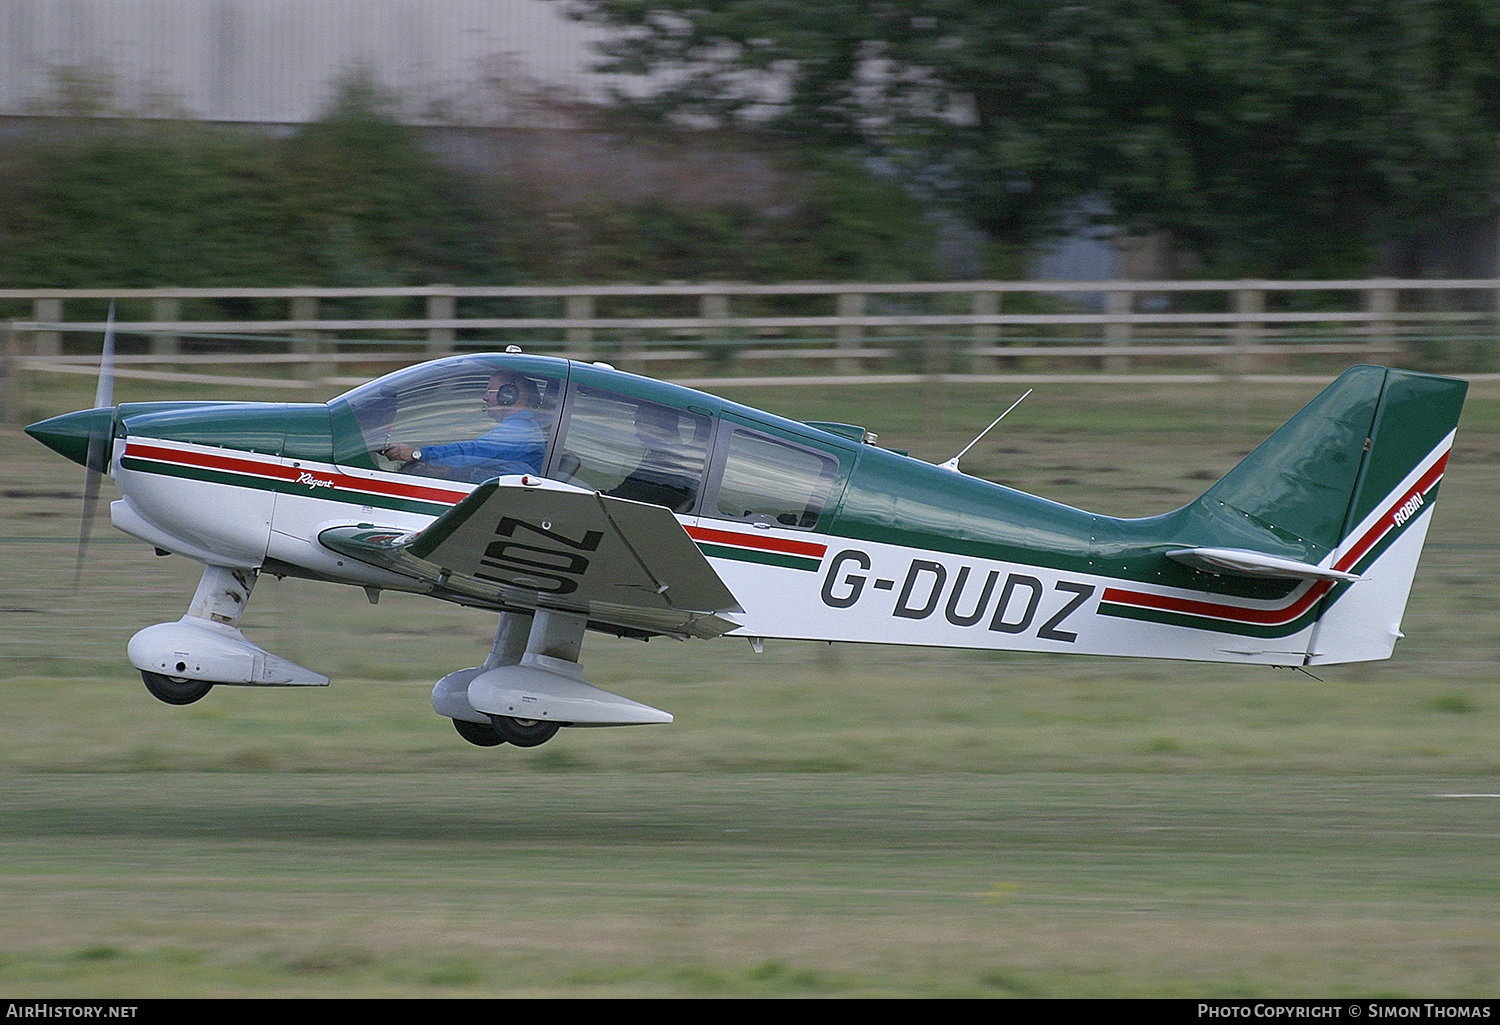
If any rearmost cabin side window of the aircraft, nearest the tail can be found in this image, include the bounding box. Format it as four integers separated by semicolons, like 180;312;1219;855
716;426;839;528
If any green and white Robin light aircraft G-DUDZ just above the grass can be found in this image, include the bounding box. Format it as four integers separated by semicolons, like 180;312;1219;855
27;339;1467;747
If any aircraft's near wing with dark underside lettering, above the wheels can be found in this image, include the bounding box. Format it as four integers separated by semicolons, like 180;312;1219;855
318;476;743;636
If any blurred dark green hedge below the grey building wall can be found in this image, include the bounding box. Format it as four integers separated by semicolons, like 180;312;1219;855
0;74;933;288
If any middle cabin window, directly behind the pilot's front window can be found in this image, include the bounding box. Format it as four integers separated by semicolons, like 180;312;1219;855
551;386;713;513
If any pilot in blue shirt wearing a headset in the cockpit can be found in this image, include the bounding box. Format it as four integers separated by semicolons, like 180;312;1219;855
384;371;546;482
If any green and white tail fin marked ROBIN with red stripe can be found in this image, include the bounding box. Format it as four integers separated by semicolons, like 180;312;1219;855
1175;366;1469;665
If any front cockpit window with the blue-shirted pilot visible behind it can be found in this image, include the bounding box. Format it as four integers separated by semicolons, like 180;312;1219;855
333;357;564;483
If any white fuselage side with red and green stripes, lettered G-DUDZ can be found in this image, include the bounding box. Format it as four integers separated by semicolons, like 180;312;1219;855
113;438;1446;665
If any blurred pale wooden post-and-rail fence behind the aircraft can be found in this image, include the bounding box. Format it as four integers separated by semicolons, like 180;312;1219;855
0;278;1500;417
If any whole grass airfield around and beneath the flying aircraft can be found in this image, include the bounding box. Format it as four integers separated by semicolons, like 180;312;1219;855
0;366;1500;998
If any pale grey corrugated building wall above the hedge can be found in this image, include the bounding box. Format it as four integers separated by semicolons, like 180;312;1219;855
0;0;603;125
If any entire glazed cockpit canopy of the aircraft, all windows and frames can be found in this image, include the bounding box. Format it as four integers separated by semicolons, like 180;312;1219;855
330;353;854;528
